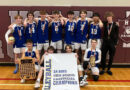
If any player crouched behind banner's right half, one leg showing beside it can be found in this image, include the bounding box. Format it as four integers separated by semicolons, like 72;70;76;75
65;45;88;86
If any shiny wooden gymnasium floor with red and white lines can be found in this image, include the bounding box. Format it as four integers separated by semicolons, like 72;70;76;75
0;66;130;90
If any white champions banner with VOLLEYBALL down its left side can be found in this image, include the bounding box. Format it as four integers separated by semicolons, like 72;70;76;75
42;53;80;90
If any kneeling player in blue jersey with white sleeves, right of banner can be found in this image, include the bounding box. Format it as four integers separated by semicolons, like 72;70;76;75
83;39;101;81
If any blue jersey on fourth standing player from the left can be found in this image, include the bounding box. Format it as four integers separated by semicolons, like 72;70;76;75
51;21;62;42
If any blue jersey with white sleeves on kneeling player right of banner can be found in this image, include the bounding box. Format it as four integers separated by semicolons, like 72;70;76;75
84;48;101;63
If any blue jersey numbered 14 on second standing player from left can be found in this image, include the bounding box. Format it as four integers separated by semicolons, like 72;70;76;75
25;22;37;46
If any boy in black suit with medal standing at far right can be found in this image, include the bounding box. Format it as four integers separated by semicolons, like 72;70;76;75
100;12;119;75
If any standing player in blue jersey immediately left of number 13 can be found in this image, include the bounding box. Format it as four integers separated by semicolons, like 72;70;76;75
75;10;92;58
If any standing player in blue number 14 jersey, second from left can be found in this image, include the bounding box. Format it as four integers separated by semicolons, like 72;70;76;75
24;12;37;48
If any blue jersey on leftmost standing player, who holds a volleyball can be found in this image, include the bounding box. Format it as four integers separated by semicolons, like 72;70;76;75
13;24;25;48
